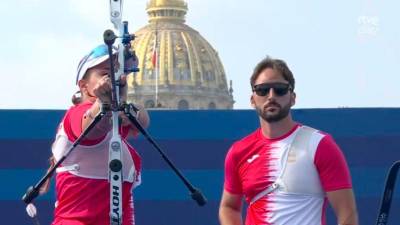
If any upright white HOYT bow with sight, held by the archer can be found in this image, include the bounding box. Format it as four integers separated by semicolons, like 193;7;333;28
104;0;137;225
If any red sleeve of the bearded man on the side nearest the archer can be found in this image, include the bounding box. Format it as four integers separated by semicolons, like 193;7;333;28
224;146;243;194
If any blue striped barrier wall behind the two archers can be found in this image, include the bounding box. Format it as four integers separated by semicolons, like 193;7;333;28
0;108;400;225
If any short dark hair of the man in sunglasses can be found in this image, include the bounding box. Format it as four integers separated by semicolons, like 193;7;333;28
250;56;295;91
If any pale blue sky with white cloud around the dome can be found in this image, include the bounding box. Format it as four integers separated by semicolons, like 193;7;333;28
0;0;400;109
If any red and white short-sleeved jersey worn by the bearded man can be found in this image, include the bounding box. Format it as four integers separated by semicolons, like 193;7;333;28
224;125;351;225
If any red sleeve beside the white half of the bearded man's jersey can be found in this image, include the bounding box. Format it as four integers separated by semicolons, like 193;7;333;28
314;135;352;192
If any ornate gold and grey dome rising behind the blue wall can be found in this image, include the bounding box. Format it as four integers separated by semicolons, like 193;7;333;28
128;0;234;109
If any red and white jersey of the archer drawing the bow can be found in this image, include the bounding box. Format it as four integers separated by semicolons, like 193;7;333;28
52;102;141;225
